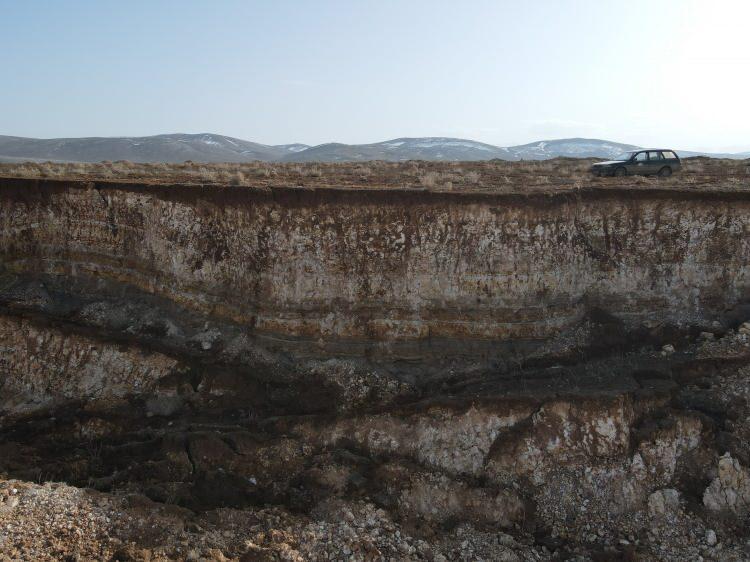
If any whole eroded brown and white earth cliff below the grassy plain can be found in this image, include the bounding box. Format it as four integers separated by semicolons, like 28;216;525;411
0;180;750;560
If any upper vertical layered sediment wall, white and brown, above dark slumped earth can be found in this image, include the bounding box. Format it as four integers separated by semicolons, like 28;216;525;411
0;179;750;350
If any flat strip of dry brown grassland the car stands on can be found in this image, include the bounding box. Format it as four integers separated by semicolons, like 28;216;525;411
0;158;750;192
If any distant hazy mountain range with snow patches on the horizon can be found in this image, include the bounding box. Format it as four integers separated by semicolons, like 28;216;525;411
0;133;750;162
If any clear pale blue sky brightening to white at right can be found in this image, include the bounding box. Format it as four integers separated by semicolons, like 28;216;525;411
0;0;750;151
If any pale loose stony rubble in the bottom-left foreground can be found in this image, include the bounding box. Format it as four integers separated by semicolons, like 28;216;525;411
0;480;549;561
